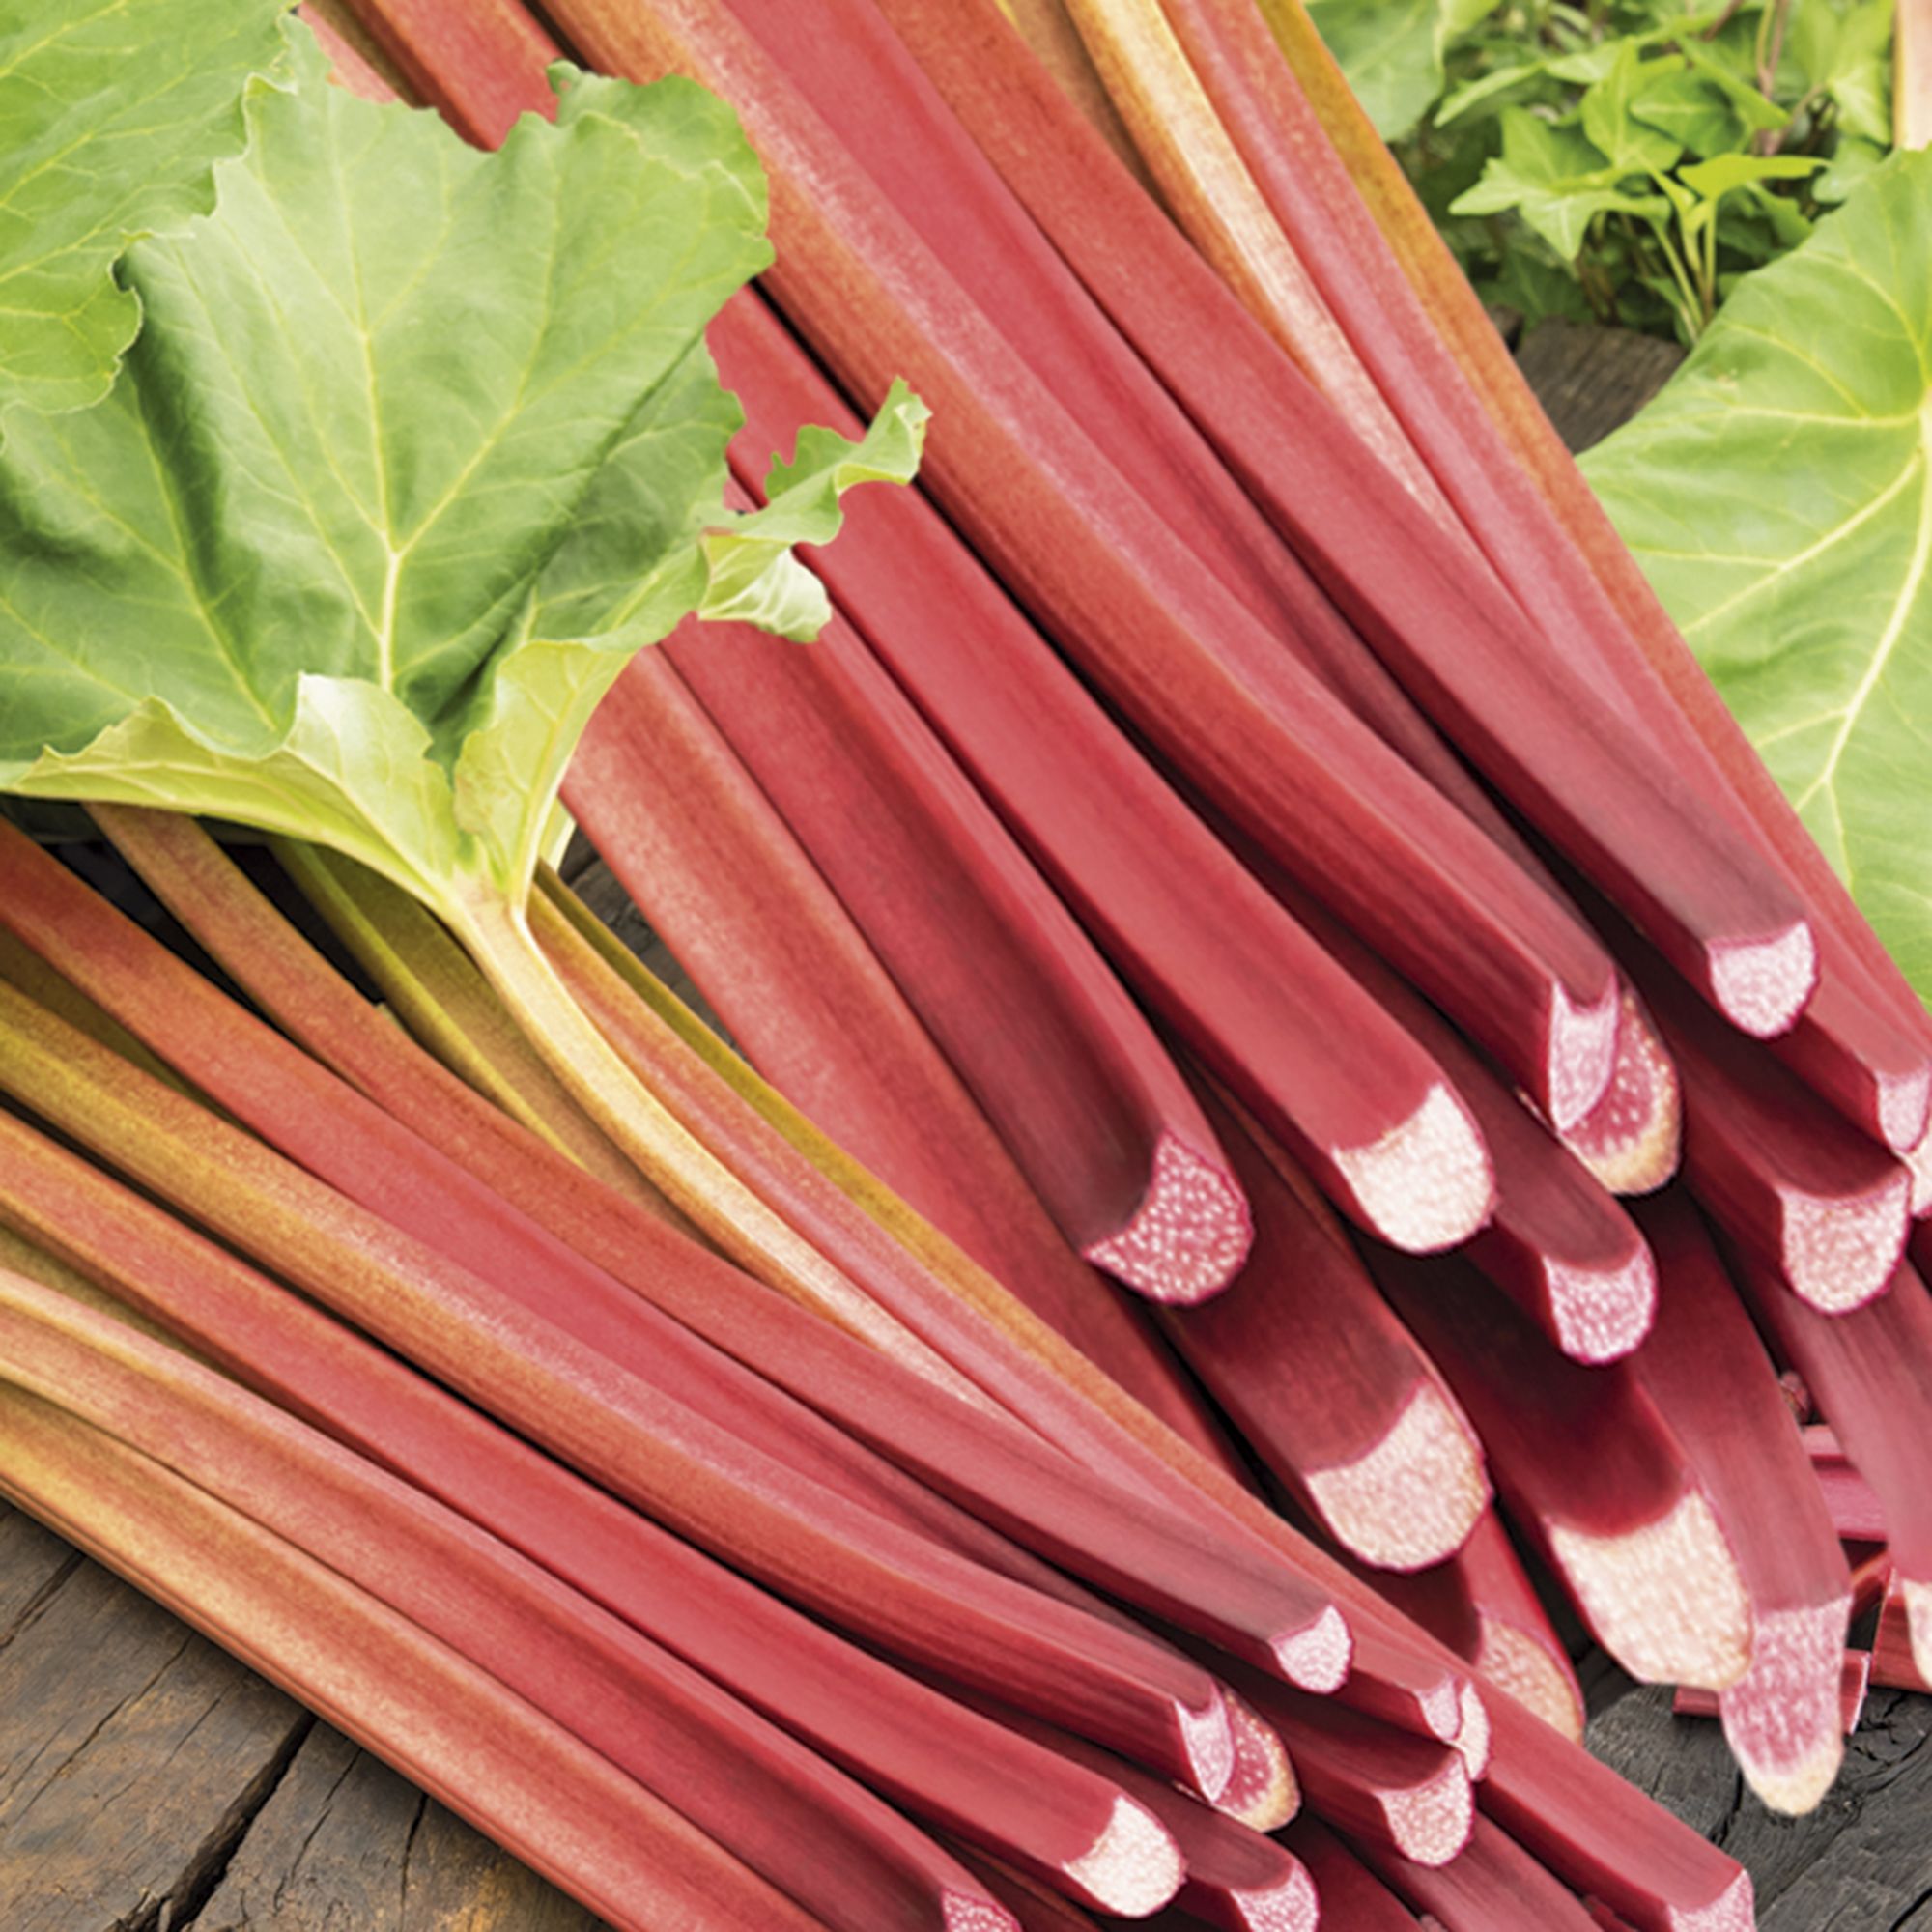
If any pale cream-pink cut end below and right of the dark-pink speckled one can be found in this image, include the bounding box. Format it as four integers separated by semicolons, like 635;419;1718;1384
1308;1381;1490;1571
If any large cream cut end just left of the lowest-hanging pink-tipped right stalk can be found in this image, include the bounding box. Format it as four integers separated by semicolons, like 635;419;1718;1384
1549;1490;1750;1690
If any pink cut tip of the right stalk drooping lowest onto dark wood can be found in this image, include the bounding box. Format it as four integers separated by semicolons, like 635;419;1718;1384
1718;1598;1851;1818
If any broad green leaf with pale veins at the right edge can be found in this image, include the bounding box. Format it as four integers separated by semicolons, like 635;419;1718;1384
1584;155;1932;995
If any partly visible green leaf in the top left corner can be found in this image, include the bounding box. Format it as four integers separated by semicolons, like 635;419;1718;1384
0;0;286;415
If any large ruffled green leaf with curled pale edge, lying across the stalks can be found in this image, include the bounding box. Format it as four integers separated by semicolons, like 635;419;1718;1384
0;48;923;902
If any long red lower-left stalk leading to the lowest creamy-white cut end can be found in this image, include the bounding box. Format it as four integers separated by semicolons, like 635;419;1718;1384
0;1115;1206;1903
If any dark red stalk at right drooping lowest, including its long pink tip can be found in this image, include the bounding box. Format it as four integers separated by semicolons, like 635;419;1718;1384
1631;1194;1851;1812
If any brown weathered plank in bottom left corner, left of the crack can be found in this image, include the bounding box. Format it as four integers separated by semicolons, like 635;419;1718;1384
0;1505;313;1932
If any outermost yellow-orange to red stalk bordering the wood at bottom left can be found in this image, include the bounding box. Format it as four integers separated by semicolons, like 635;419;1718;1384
0;1389;819;1932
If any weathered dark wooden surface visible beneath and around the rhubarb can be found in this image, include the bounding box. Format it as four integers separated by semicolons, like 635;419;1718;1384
0;327;1932;1932
